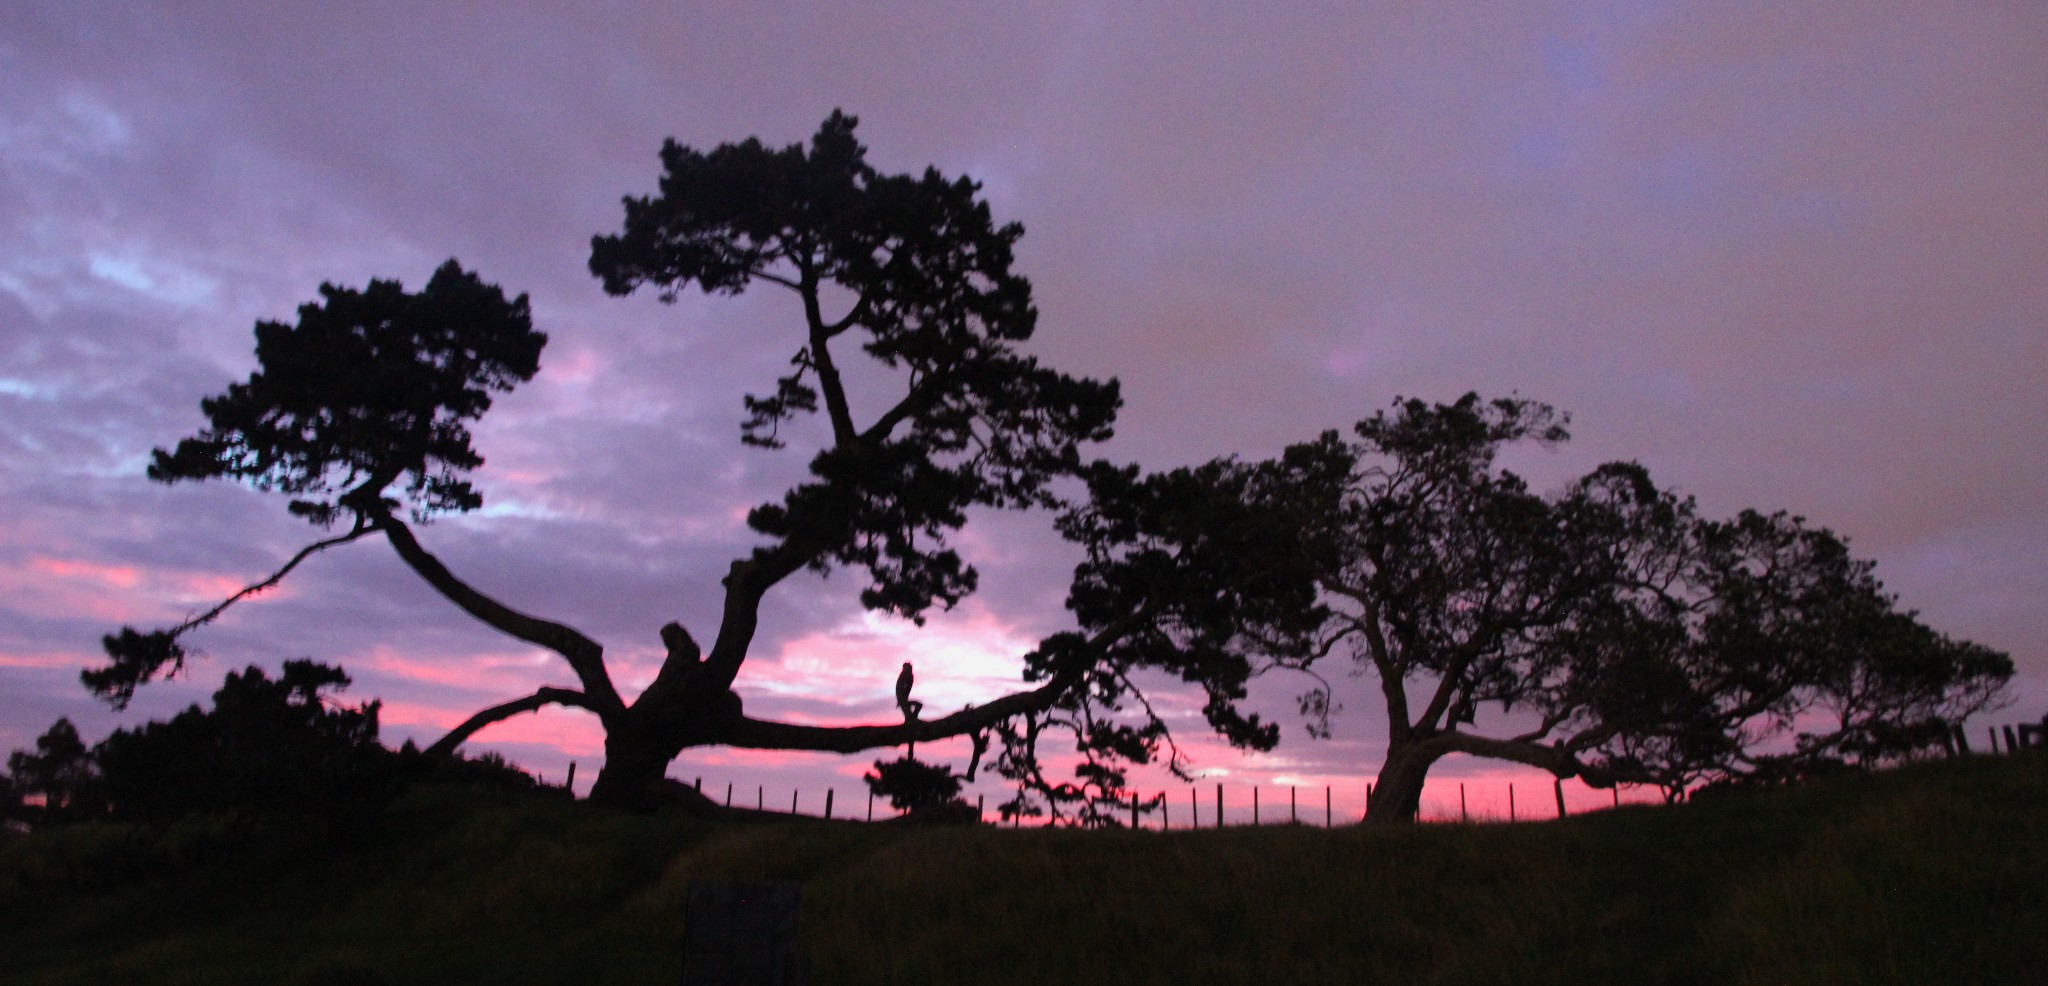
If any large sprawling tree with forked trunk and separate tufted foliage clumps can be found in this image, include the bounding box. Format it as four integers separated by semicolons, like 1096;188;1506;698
86;113;1272;806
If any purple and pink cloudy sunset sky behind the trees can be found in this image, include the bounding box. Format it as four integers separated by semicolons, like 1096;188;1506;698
0;0;2048;820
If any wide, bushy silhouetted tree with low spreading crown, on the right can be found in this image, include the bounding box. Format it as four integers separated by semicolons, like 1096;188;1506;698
1196;394;2011;820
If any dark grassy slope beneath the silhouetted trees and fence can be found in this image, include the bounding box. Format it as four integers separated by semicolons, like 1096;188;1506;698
0;756;2048;986
